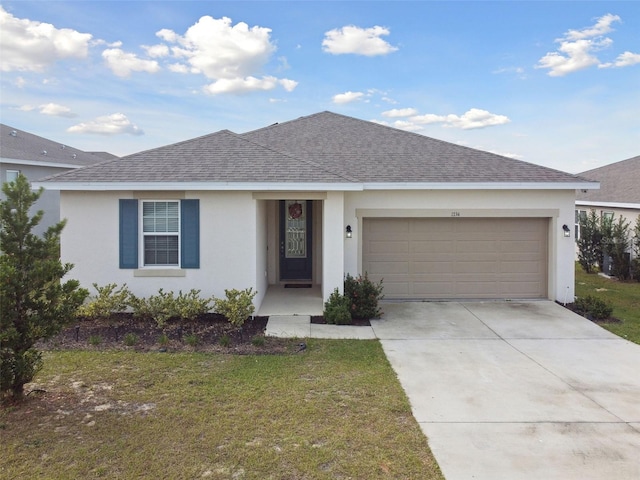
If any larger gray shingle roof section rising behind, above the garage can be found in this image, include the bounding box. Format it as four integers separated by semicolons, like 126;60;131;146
242;112;583;183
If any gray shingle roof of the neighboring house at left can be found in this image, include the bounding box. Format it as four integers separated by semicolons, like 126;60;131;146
0;124;104;167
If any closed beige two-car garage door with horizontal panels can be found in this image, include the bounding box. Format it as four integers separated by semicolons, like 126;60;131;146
362;218;548;299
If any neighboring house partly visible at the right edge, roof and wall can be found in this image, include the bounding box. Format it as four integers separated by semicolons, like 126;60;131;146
575;156;640;239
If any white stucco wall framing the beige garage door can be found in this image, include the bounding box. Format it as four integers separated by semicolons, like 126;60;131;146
343;190;575;301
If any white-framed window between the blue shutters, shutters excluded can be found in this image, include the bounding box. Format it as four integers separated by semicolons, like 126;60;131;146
142;201;180;266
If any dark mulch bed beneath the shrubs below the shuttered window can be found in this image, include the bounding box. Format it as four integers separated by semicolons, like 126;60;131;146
38;313;298;354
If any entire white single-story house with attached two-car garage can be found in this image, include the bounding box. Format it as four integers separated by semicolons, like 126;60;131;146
40;112;598;307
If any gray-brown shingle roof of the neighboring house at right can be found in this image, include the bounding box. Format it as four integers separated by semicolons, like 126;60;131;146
576;155;640;204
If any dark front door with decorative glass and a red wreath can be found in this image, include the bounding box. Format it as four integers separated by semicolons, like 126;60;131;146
280;200;311;280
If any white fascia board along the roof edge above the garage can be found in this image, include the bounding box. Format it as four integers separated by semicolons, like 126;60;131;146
364;182;600;190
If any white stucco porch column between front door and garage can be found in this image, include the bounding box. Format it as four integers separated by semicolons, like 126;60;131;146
322;192;345;301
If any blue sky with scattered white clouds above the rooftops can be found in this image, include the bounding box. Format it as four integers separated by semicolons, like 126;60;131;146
0;1;640;173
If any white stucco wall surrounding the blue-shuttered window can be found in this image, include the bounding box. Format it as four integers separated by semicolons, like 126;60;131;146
61;191;265;297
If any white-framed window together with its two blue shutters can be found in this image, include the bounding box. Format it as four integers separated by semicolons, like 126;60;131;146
120;199;200;269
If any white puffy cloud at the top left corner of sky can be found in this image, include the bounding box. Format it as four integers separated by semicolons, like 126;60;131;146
0;6;92;72
